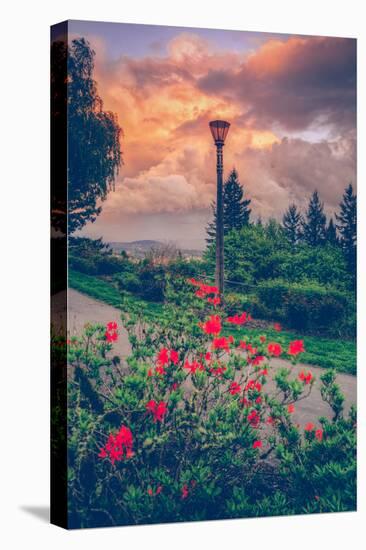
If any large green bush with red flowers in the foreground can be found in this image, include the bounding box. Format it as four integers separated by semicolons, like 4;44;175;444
68;279;355;527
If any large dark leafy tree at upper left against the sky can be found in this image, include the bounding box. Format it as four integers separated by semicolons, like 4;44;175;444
52;38;122;233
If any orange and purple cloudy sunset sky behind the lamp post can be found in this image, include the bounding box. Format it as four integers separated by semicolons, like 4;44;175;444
69;21;356;248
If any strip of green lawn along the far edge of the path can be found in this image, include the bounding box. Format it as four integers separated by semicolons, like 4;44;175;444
69;270;356;374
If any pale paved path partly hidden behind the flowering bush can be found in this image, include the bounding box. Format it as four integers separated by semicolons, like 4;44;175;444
64;289;357;425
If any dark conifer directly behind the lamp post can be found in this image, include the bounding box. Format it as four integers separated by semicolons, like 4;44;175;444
206;168;251;244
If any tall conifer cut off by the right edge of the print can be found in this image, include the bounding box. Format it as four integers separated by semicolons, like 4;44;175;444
336;184;357;275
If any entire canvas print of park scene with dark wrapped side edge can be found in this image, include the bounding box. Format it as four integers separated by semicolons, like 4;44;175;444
51;21;357;528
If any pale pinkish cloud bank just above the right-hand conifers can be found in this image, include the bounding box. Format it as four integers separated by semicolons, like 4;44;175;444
230;137;356;219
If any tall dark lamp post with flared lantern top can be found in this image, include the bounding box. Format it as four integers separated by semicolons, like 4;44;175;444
210;120;230;296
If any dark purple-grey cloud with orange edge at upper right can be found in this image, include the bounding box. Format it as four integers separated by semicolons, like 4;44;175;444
198;37;356;130
